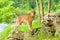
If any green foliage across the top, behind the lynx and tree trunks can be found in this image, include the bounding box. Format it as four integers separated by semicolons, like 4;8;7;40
0;0;60;22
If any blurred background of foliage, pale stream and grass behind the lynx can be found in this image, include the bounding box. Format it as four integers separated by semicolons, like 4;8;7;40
0;0;60;38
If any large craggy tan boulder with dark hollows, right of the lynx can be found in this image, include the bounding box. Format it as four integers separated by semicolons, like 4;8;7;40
42;12;60;35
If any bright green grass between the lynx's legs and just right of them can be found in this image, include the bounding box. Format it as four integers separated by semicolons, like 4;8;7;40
18;20;41;32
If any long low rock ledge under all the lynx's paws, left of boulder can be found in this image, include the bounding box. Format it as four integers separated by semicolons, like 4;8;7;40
8;27;51;40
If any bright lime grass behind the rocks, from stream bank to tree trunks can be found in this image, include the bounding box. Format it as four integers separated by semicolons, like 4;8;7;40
0;20;41;39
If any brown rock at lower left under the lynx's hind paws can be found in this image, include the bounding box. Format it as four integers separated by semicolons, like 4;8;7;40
8;30;24;40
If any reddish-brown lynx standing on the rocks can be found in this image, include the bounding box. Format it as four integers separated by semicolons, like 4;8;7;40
14;10;36;31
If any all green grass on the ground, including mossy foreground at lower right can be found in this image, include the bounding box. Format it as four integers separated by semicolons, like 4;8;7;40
0;20;60;40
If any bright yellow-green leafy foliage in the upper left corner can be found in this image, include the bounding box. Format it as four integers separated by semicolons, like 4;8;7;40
0;0;14;22
